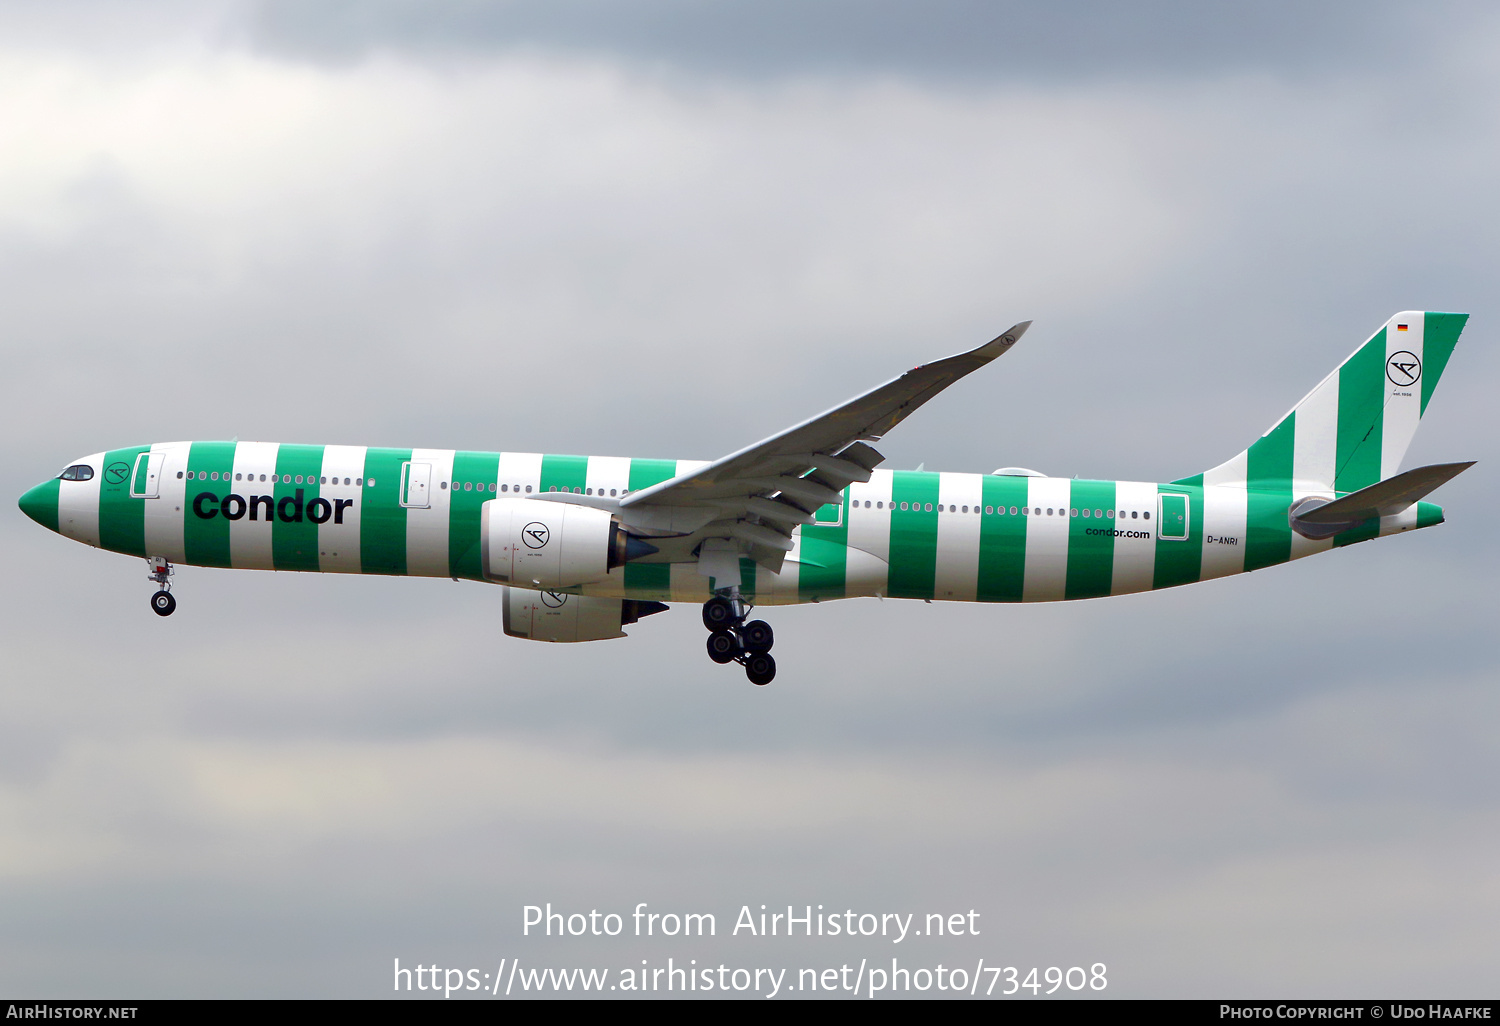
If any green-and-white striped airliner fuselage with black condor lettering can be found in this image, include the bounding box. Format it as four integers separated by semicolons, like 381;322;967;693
14;444;1443;605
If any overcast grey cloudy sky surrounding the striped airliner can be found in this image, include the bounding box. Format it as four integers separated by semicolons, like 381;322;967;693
0;0;1500;998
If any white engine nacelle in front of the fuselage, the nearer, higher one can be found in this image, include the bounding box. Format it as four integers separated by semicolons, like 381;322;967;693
480;500;657;588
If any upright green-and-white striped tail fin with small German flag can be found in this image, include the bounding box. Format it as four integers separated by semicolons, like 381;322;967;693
1181;311;1469;494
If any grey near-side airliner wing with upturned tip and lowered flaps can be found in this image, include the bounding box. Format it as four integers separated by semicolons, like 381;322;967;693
620;321;1031;570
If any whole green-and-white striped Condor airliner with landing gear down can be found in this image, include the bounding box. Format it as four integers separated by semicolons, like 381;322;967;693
20;311;1473;684
